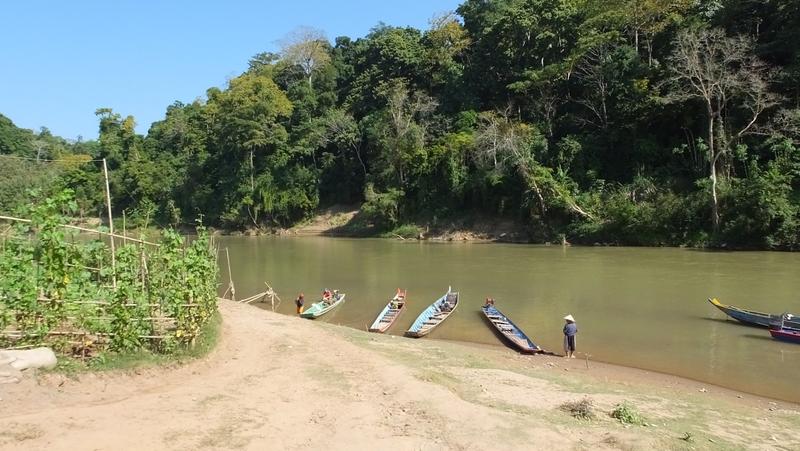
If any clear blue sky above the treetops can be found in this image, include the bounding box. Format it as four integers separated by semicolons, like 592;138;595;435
0;0;460;139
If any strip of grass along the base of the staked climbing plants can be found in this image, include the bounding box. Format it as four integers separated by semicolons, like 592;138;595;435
52;312;222;376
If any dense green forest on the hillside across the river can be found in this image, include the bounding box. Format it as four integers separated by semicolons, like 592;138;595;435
0;0;800;250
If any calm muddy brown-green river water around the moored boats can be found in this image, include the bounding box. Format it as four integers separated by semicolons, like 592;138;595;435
220;237;800;402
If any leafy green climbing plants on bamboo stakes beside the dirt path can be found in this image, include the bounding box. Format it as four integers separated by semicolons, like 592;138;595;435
0;191;217;357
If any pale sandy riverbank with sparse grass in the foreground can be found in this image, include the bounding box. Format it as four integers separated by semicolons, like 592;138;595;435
0;302;800;450
